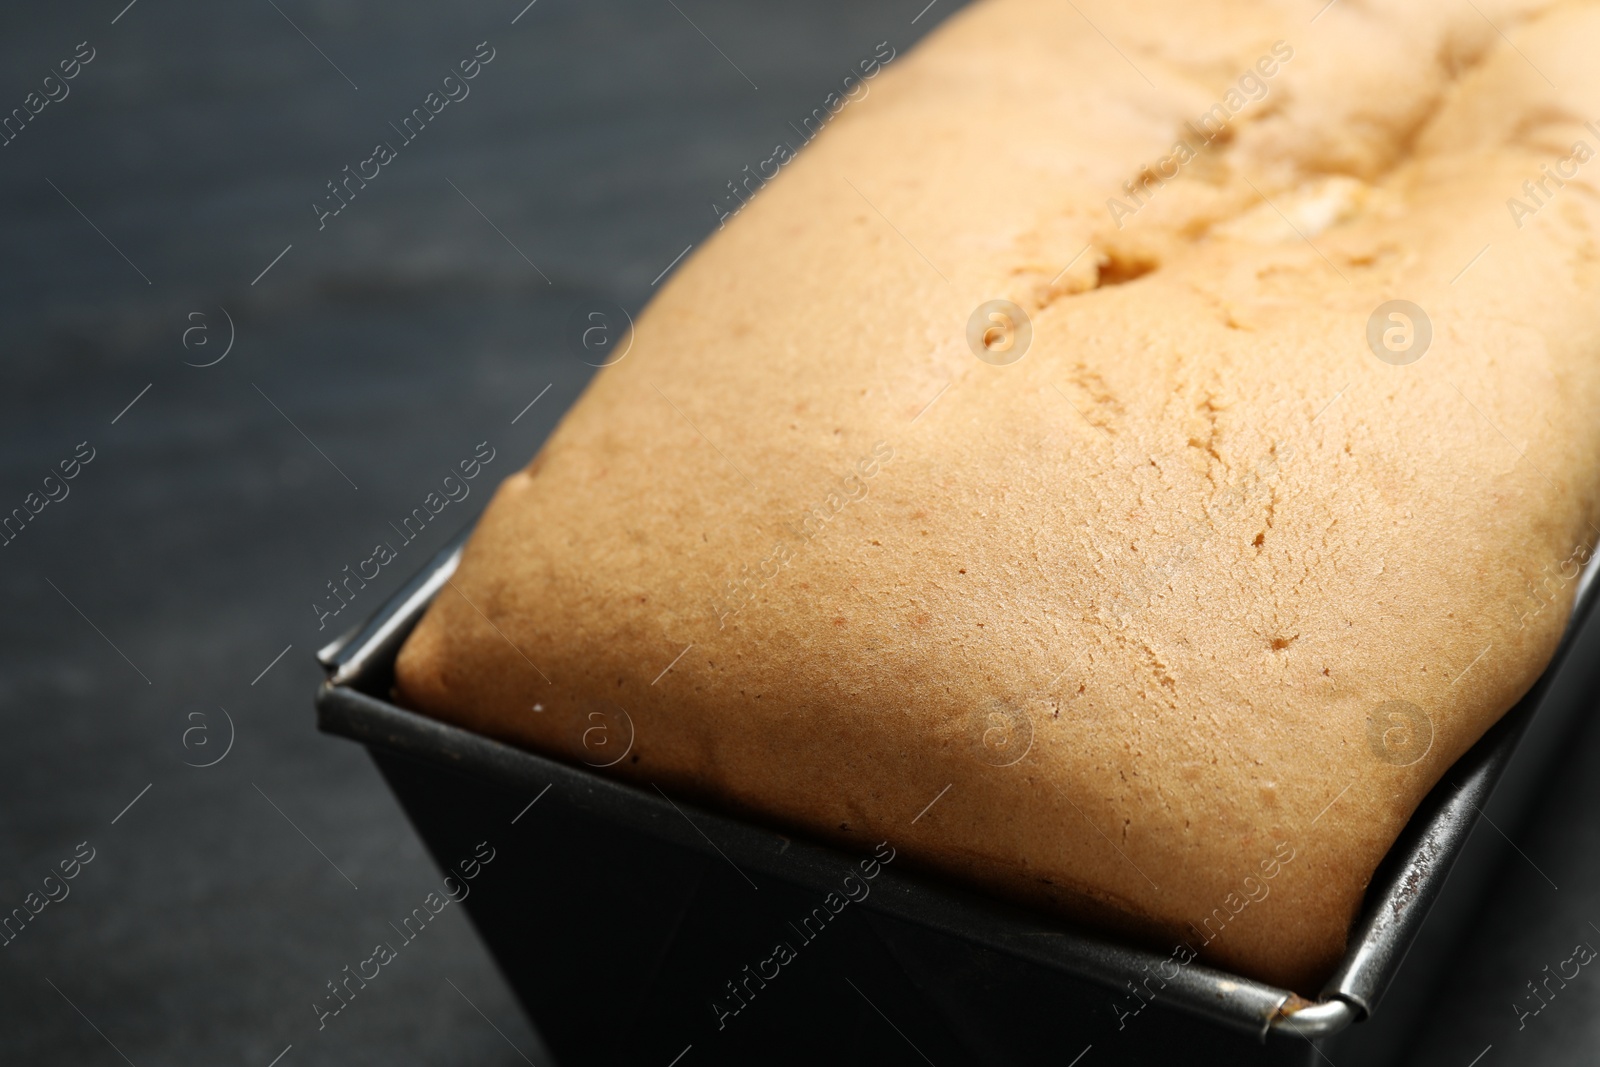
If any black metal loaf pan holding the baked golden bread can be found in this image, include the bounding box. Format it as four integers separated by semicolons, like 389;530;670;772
317;531;1600;1067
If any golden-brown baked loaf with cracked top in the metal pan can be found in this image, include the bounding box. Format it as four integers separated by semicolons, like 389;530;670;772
397;0;1600;993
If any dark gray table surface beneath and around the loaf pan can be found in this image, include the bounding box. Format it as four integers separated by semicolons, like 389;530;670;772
0;0;1600;1067
